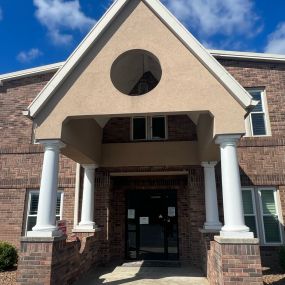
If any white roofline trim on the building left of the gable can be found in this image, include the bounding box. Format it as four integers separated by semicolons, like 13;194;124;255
0;62;64;83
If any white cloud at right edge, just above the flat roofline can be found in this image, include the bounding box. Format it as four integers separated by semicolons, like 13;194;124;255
265;22;285;54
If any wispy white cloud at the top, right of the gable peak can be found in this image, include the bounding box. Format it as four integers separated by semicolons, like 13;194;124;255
163;0;262;36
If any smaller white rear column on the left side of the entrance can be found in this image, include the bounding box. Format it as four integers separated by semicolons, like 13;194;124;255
78;165;98;230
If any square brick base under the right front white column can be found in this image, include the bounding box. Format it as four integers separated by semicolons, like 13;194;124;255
208;236;263;285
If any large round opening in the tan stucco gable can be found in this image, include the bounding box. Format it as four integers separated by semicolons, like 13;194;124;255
111;49;162;96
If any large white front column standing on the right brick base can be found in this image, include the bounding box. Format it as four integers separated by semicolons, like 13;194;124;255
216;135;253;238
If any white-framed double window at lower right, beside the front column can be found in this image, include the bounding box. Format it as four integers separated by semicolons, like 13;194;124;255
242;187;282;245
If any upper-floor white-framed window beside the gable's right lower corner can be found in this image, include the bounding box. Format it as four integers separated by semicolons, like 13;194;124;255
246;89;269;136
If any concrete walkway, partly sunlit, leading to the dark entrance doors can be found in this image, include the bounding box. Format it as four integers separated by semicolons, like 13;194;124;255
75;266;209;285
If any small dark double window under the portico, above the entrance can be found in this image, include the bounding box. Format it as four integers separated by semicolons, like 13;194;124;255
132;116;167;141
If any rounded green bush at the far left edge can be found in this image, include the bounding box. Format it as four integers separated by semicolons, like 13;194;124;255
0;242;18;271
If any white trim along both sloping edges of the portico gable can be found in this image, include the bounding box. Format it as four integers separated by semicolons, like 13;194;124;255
28;0;256;117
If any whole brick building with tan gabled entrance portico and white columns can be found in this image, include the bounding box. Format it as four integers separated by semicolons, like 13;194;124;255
0;0;285;284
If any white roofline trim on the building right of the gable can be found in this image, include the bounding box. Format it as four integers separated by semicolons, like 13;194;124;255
209;49;285;62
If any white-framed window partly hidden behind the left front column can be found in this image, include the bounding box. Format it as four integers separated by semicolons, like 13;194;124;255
25;190;63;233
